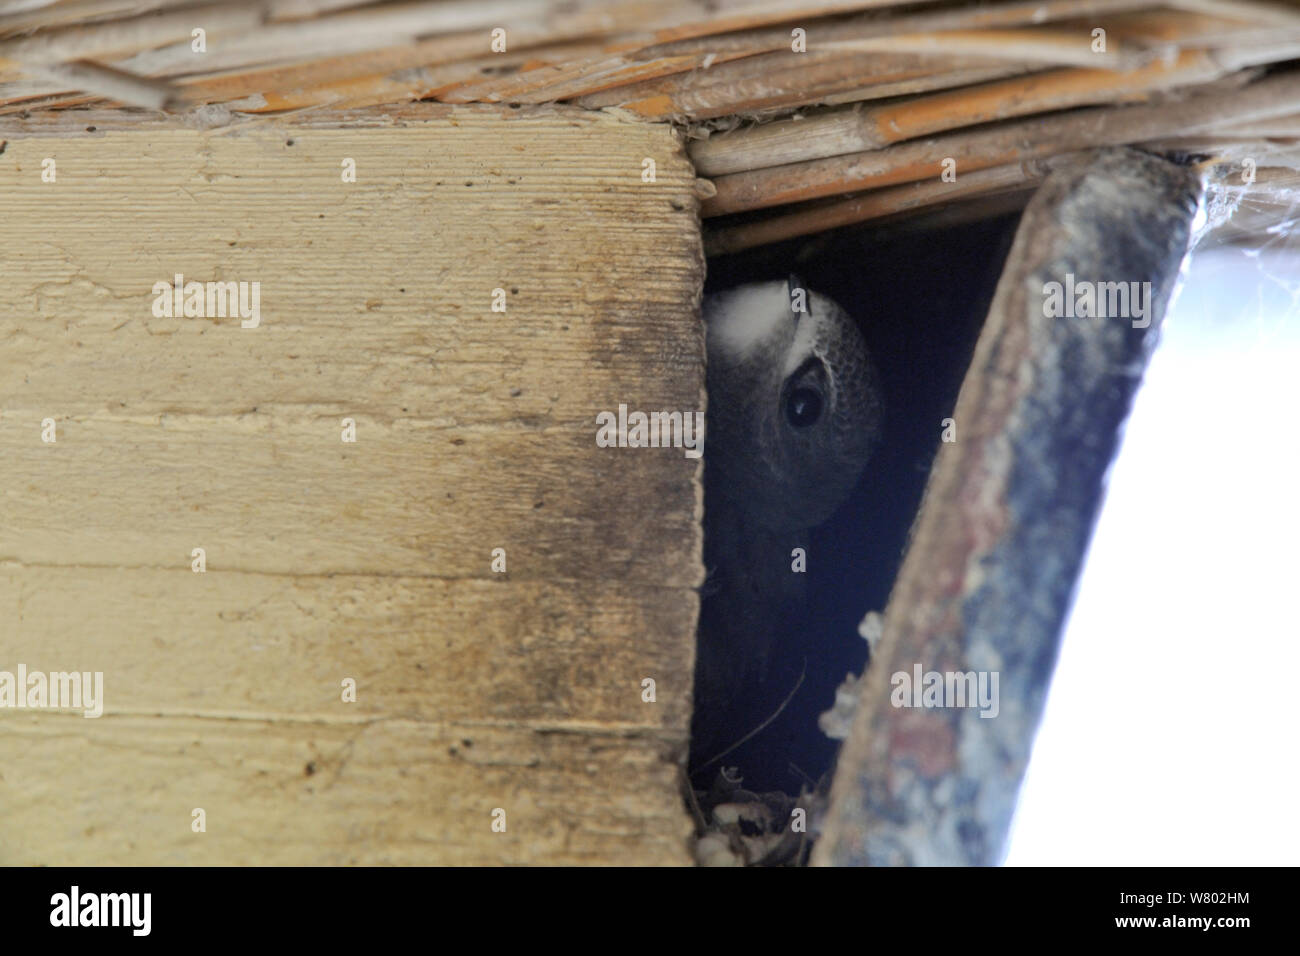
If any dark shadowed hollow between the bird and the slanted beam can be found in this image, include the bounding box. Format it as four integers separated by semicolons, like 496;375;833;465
690;212;1019;793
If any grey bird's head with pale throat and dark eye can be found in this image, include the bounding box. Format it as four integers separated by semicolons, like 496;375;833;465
703;276;881;531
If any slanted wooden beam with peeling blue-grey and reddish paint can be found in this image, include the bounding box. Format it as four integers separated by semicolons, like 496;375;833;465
813;150;1201;865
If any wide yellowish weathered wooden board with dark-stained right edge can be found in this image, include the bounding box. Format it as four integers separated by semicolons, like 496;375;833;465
0;107;703;864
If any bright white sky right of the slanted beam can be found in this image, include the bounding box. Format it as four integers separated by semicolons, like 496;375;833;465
1006;239;1300;866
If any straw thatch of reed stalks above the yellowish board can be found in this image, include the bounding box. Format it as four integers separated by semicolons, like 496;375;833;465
0;0;1300;252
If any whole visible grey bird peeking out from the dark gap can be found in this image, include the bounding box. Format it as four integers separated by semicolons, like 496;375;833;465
696;277;881;744
